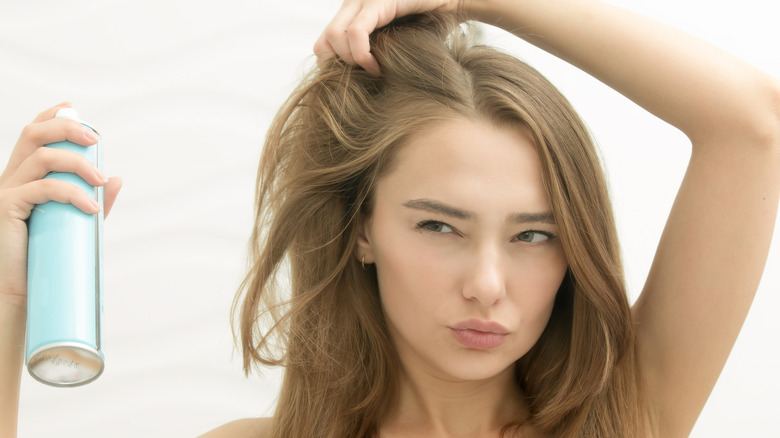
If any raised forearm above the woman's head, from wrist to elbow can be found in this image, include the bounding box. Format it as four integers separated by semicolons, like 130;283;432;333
464;0;780;149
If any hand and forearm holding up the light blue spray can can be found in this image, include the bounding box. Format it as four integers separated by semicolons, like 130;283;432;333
0;103;122;436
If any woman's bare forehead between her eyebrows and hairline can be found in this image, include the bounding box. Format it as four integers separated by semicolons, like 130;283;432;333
377;118;549;216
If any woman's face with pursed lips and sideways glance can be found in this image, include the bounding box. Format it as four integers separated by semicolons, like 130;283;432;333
357;118;567;380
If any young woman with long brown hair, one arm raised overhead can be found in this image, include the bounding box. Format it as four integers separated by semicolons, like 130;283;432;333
0;0;780;437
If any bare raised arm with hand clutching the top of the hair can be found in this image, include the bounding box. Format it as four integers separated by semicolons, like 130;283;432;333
315;0;780;437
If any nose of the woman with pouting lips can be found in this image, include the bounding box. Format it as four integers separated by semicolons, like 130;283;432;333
463;248;507;306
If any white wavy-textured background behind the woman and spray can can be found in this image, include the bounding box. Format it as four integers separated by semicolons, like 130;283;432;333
0;0;780;437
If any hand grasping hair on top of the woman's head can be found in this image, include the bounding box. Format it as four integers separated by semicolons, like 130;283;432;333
314;0;464;75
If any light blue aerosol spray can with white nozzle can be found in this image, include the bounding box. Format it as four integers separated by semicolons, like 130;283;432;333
26;108;104;386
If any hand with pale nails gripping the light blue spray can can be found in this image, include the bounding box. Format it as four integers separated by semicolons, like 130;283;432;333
0;103;122;304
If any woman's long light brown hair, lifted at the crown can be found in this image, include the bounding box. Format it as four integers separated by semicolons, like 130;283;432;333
234;14;645;438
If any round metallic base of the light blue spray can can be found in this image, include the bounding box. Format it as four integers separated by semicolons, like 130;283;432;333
27;342;104;386
